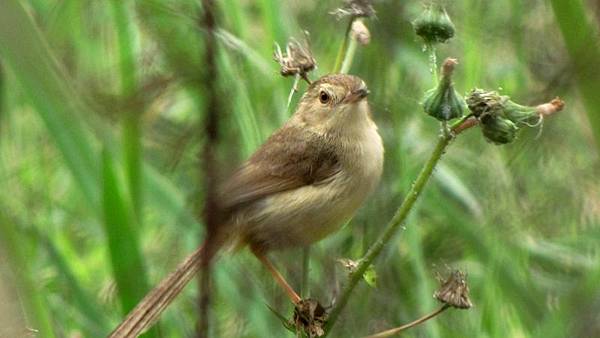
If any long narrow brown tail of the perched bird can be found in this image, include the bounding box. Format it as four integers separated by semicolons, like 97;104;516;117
108;245;216;338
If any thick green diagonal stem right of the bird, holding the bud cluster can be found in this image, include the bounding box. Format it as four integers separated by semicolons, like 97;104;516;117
325;116;474;336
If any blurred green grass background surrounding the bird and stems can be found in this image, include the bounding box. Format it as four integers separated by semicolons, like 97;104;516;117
0;0;600;337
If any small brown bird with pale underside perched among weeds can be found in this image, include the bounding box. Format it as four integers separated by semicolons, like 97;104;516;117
110;74;383;337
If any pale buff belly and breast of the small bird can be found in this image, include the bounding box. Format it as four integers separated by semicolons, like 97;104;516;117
238;128;383;251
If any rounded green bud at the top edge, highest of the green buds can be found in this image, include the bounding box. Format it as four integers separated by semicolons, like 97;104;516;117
413;4;455;44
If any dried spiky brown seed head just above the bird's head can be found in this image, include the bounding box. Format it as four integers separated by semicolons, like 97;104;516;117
273;32;317;79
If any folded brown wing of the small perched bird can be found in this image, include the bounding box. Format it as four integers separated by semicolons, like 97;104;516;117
220;127;340;210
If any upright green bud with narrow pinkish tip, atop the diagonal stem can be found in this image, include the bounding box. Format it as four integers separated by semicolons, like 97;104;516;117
423;58;465;121
